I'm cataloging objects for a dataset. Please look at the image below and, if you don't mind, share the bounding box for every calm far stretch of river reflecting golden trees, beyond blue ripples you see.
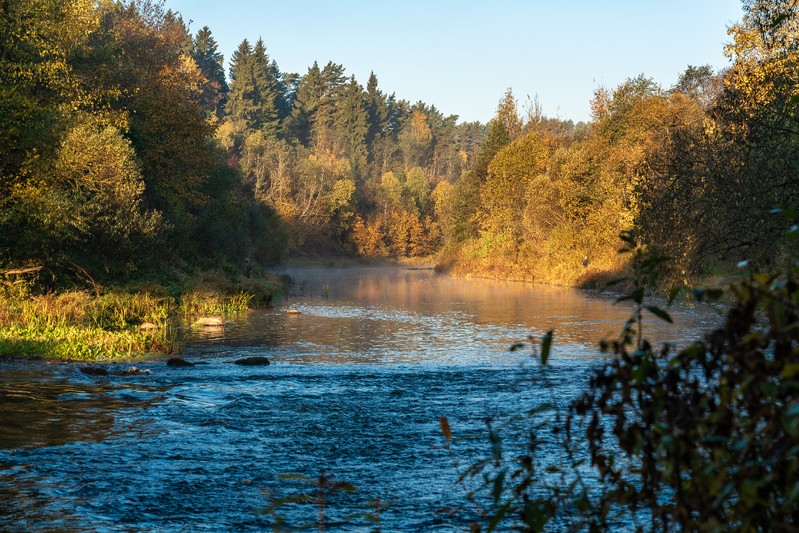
[209,267,717,364]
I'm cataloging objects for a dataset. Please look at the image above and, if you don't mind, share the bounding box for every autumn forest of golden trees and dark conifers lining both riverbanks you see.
[0,0,799,284]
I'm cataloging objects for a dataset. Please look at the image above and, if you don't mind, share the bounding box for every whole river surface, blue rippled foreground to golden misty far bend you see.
[0,267,719,531]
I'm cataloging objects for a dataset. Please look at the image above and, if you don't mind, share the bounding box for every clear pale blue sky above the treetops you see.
[166,0,742,122]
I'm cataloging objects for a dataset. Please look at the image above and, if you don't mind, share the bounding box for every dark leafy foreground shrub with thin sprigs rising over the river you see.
[450,234,799,531]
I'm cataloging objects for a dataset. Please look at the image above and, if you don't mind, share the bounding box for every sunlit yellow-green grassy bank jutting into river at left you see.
[0,272,286,361]
